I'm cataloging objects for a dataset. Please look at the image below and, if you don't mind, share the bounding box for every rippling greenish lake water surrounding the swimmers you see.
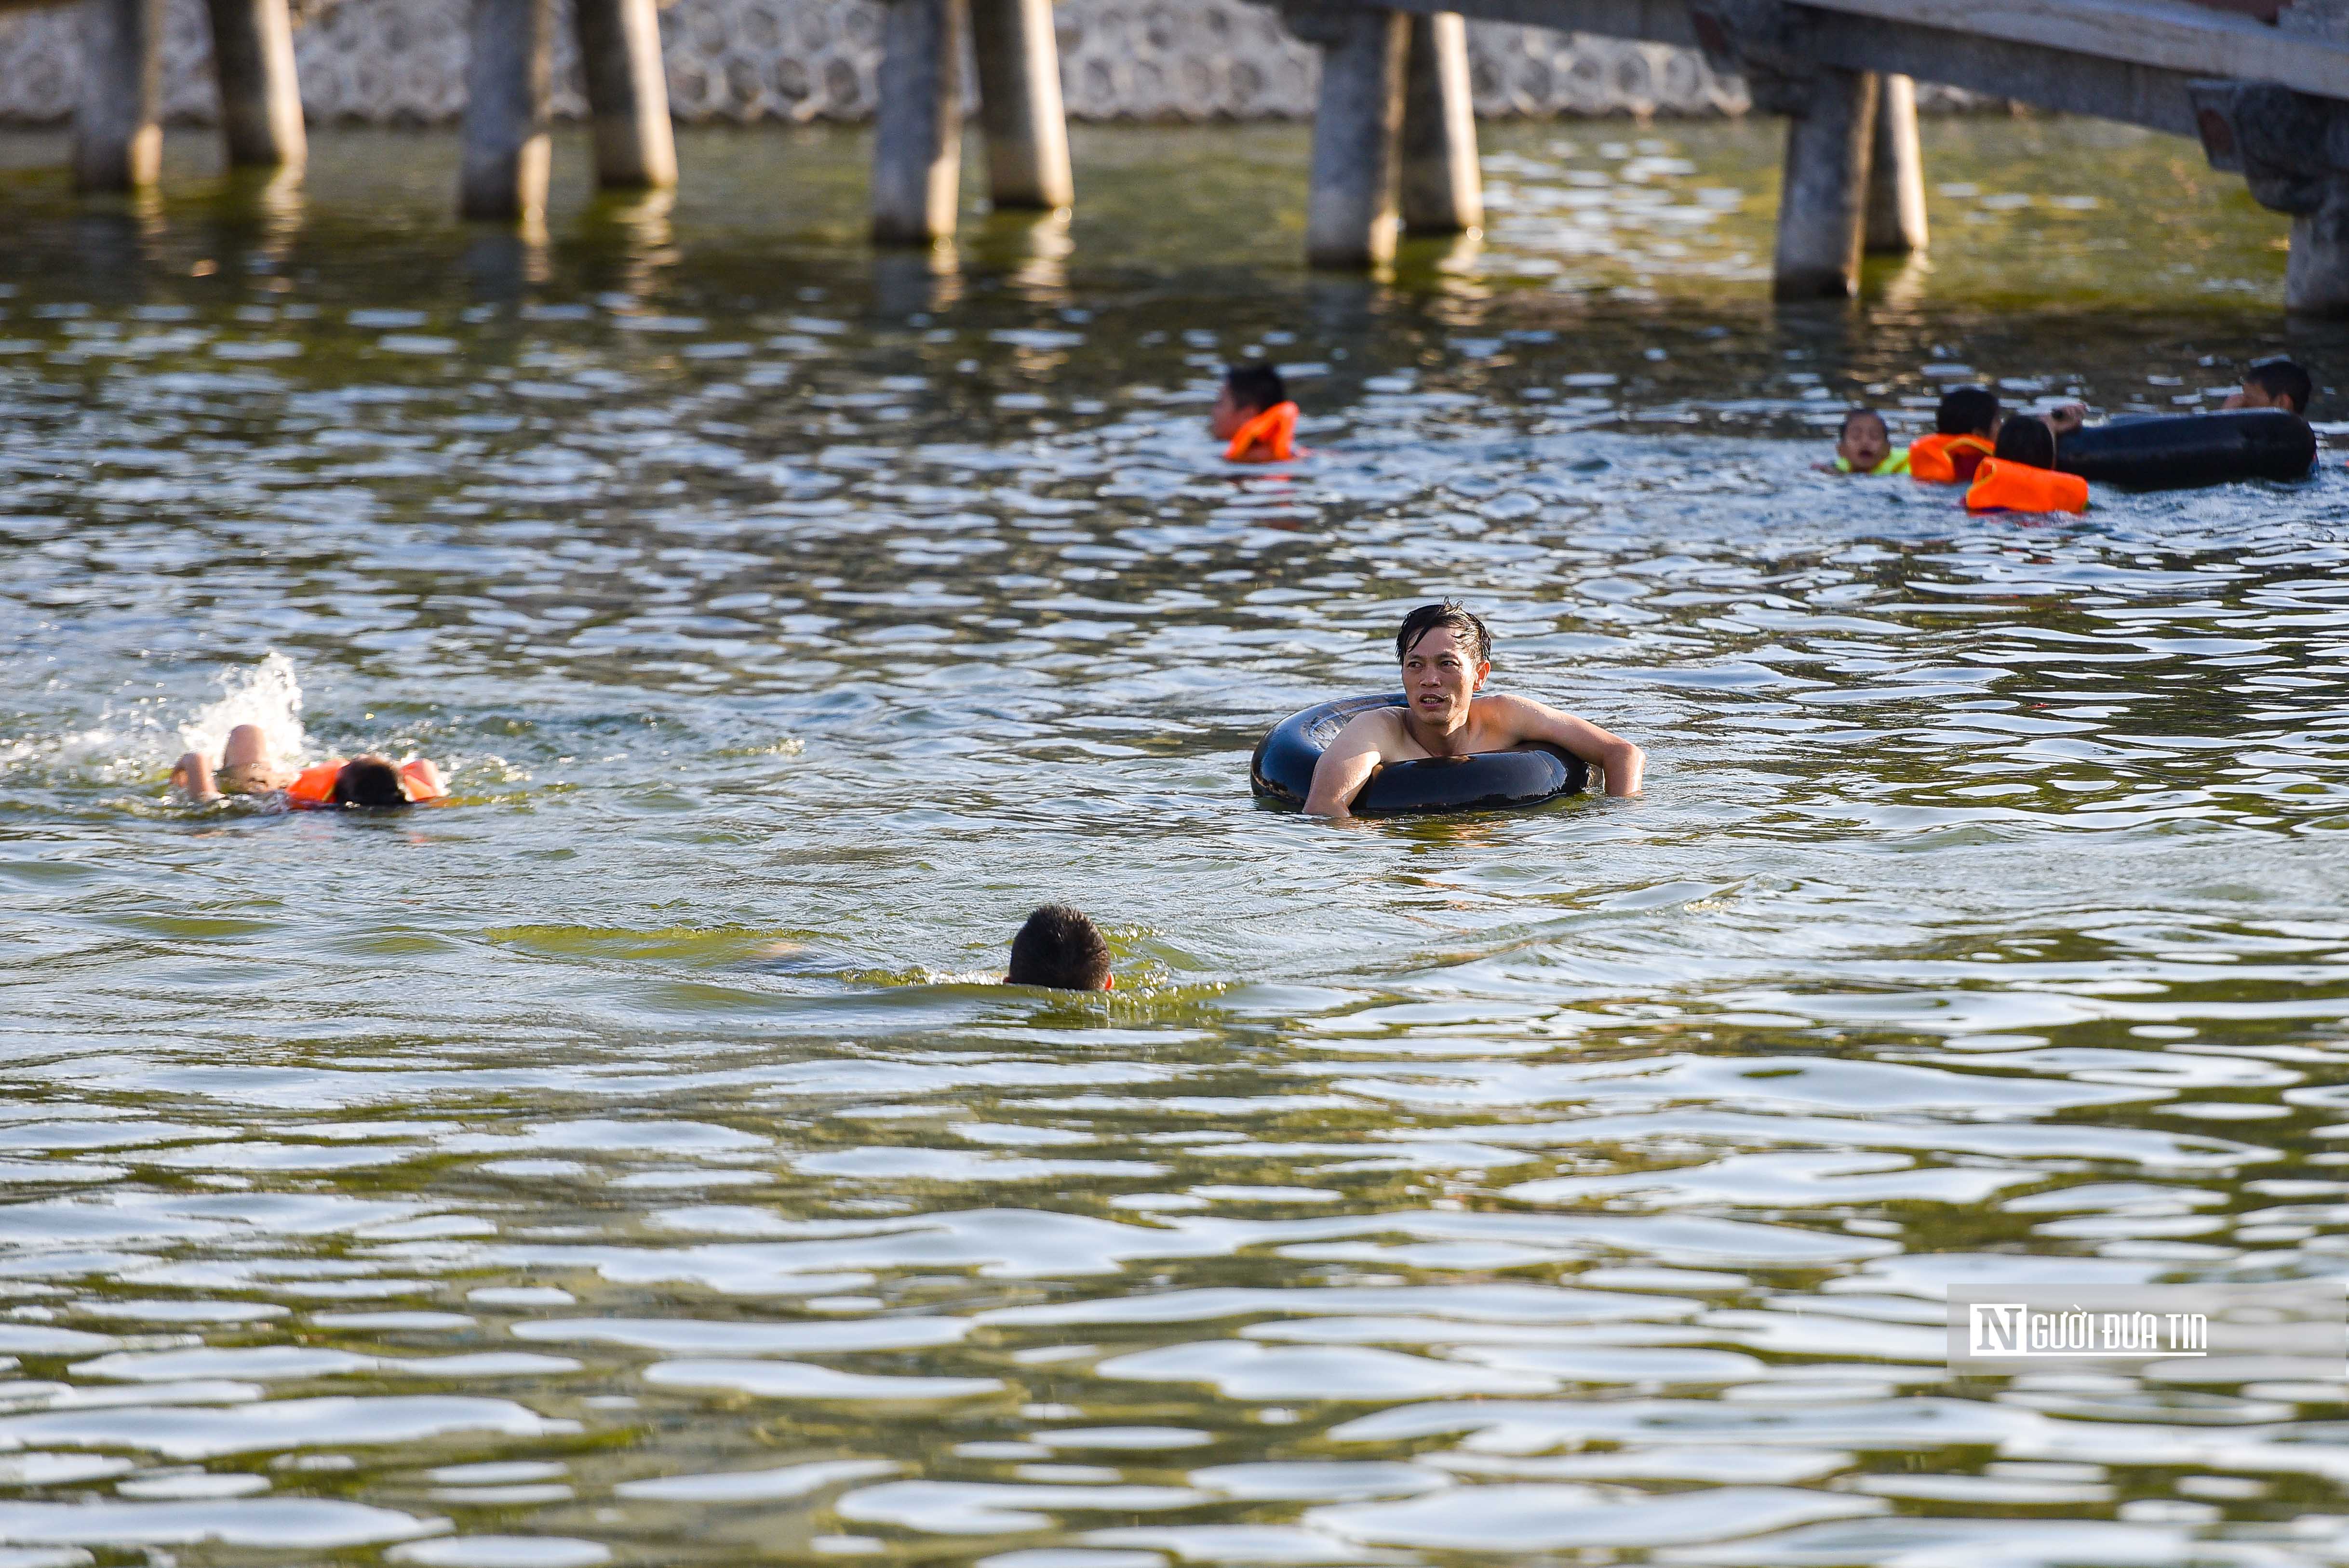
[0,120,2349,1568]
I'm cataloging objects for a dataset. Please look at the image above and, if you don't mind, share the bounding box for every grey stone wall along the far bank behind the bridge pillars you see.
[0,0,1745,124]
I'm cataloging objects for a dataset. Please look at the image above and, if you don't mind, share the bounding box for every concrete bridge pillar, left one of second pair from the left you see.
[456,0,554,223]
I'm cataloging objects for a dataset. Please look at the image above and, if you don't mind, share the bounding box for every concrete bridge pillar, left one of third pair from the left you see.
[872,0,970,244]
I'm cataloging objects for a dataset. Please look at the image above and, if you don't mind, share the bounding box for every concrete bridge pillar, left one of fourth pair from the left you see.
[1285,7,1412,270]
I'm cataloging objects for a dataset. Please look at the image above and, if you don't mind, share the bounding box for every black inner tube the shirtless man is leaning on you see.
[1248,693,1590,817]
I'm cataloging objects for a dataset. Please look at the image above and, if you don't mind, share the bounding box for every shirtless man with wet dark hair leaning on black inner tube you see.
[1306,603,1647,817]
